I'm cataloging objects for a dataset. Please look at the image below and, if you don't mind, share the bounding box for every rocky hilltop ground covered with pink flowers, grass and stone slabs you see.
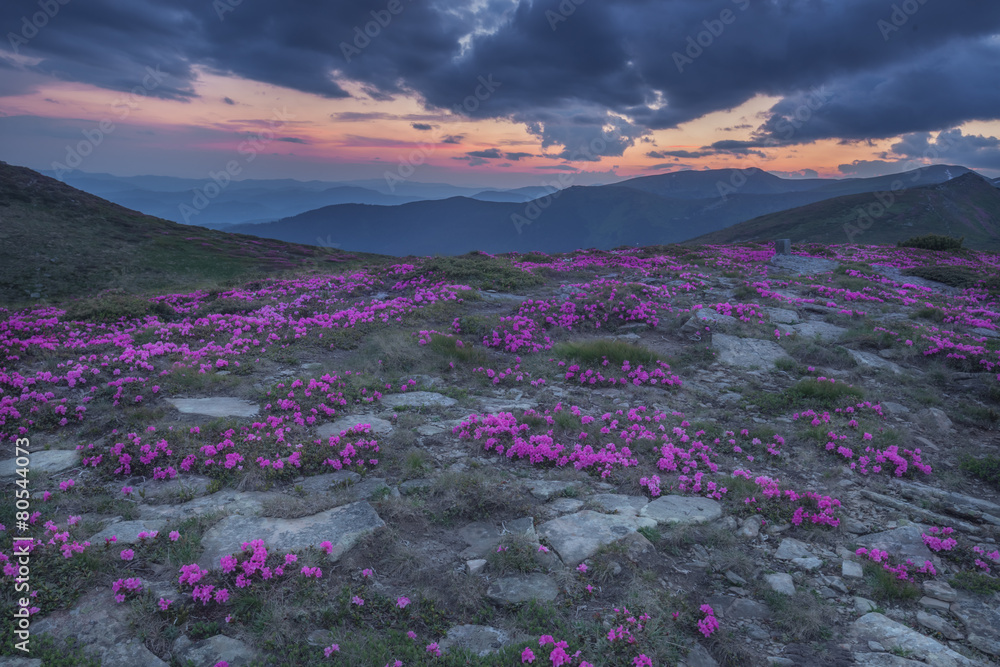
[0,247,1000,667]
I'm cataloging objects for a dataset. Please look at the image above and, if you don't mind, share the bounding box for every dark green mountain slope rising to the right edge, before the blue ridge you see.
[690,172,1000,250]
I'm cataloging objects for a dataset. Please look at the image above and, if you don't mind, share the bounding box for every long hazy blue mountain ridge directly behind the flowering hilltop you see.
[223,165,969,255]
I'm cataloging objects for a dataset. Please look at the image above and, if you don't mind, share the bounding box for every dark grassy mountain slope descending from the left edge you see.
[0,162,368,305]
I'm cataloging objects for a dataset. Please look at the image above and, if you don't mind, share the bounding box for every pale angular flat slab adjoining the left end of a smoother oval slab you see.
[538,510,656,567]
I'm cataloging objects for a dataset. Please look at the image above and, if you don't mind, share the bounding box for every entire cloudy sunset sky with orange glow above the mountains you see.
[0,0,1000,187]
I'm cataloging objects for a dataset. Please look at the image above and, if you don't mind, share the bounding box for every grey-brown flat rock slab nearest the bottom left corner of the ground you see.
[31,587,167,667]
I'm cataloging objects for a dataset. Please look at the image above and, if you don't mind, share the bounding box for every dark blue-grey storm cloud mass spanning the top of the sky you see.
[0,0,1000,161]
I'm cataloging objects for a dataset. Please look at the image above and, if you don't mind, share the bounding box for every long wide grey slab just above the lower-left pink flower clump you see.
[198,501,385,569]
